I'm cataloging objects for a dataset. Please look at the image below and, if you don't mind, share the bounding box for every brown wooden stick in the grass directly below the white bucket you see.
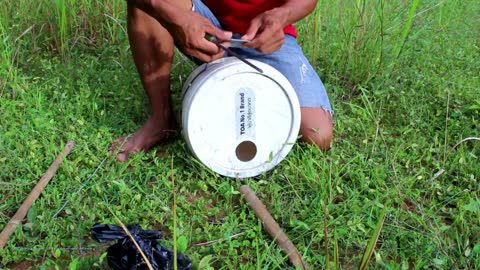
[240,185,309,269]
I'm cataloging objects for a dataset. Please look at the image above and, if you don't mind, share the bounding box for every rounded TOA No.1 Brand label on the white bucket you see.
[235,87,255,139]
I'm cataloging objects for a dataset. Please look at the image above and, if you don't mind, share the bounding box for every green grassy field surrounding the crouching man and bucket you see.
[0,0,480,269]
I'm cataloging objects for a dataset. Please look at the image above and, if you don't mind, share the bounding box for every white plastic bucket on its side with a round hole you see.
[181,57,300,178]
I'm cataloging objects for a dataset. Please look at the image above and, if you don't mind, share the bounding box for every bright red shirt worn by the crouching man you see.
[203,0,297,37]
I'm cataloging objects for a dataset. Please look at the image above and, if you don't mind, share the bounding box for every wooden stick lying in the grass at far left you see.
[0,141,75,249]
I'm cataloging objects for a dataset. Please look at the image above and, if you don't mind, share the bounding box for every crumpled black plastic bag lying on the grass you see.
[91,224,192,270]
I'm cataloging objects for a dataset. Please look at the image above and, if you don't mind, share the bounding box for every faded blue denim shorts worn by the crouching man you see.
[193,0,332,112]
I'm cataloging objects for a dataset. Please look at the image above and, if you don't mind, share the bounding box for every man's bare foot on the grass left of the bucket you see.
[109,118,178,161]
